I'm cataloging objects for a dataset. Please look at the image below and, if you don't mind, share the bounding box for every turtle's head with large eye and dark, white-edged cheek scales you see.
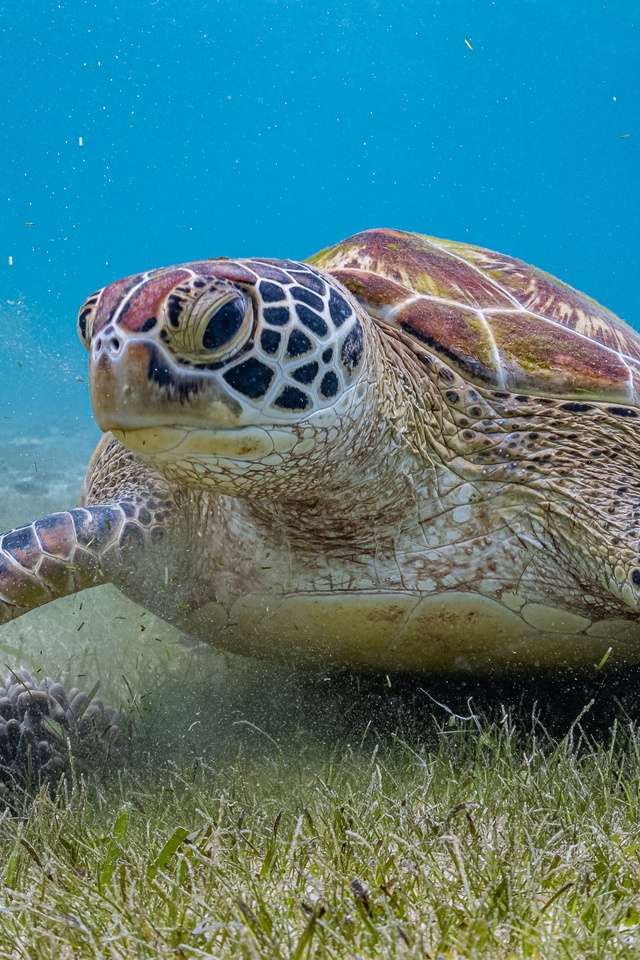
[78,259,376,492]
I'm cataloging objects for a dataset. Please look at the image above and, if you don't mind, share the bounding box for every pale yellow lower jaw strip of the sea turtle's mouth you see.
[111,424,300,461]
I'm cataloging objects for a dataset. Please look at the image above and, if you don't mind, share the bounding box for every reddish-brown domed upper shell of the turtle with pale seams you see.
[309,229,640,403]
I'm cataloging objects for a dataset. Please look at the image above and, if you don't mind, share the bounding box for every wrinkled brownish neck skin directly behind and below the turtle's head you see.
[152,322,428,555]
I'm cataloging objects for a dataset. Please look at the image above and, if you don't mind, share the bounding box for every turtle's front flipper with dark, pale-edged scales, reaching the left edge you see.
[0,499,164,623]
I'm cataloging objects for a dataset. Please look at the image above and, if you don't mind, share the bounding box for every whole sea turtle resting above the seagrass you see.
[0,229,640,671]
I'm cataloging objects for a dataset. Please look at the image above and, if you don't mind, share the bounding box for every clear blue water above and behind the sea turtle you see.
[0,0,640,431]
